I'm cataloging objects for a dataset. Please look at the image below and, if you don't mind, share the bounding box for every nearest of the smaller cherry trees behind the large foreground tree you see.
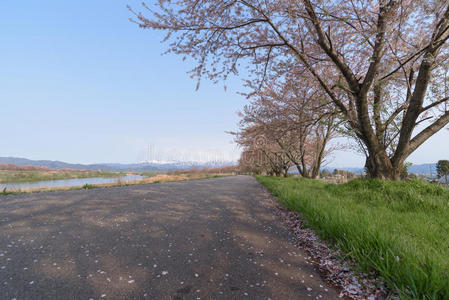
[237,78,339,178]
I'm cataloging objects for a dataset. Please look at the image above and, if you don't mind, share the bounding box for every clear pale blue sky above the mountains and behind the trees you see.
[0,0,448,167]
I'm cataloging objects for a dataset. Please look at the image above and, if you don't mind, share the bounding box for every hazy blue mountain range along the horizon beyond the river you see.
[0,157,236,171]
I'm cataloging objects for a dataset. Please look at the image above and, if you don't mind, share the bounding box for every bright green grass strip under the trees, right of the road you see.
[257,176,449,299]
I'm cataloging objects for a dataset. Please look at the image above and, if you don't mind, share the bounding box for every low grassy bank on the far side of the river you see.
[0,170,124,183]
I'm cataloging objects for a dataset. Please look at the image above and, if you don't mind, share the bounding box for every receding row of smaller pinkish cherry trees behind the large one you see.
[234,78,339,178]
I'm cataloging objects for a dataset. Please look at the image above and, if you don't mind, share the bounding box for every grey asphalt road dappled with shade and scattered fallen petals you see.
[0,176,338,300]
